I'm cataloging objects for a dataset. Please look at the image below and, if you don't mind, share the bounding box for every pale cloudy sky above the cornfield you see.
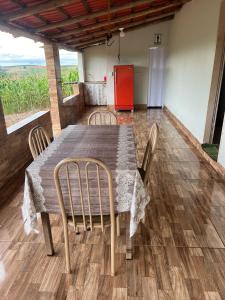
[0,31,77,66]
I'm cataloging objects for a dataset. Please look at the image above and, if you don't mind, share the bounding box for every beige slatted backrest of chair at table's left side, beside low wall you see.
[28,125,51,159]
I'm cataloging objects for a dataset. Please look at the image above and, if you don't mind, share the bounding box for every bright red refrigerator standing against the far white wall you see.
[114,65,134,111]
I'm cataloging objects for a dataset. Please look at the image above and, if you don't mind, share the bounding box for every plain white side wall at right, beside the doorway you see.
[165,0,221,143]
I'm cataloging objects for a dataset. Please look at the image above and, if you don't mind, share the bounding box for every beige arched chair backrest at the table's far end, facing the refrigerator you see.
[88,110,117,125]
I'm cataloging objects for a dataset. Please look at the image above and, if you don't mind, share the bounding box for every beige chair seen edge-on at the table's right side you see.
[138,123,159,186]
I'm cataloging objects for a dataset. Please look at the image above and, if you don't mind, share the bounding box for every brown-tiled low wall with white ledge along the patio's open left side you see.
[0,84,85,205]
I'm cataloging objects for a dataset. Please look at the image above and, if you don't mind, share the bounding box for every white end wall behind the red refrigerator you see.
[84,21,171,104]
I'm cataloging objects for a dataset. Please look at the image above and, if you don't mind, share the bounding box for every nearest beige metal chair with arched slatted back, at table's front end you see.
[54,158,115,276]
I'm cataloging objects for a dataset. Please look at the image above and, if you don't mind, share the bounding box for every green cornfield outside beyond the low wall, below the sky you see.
[0,66,79,115]
